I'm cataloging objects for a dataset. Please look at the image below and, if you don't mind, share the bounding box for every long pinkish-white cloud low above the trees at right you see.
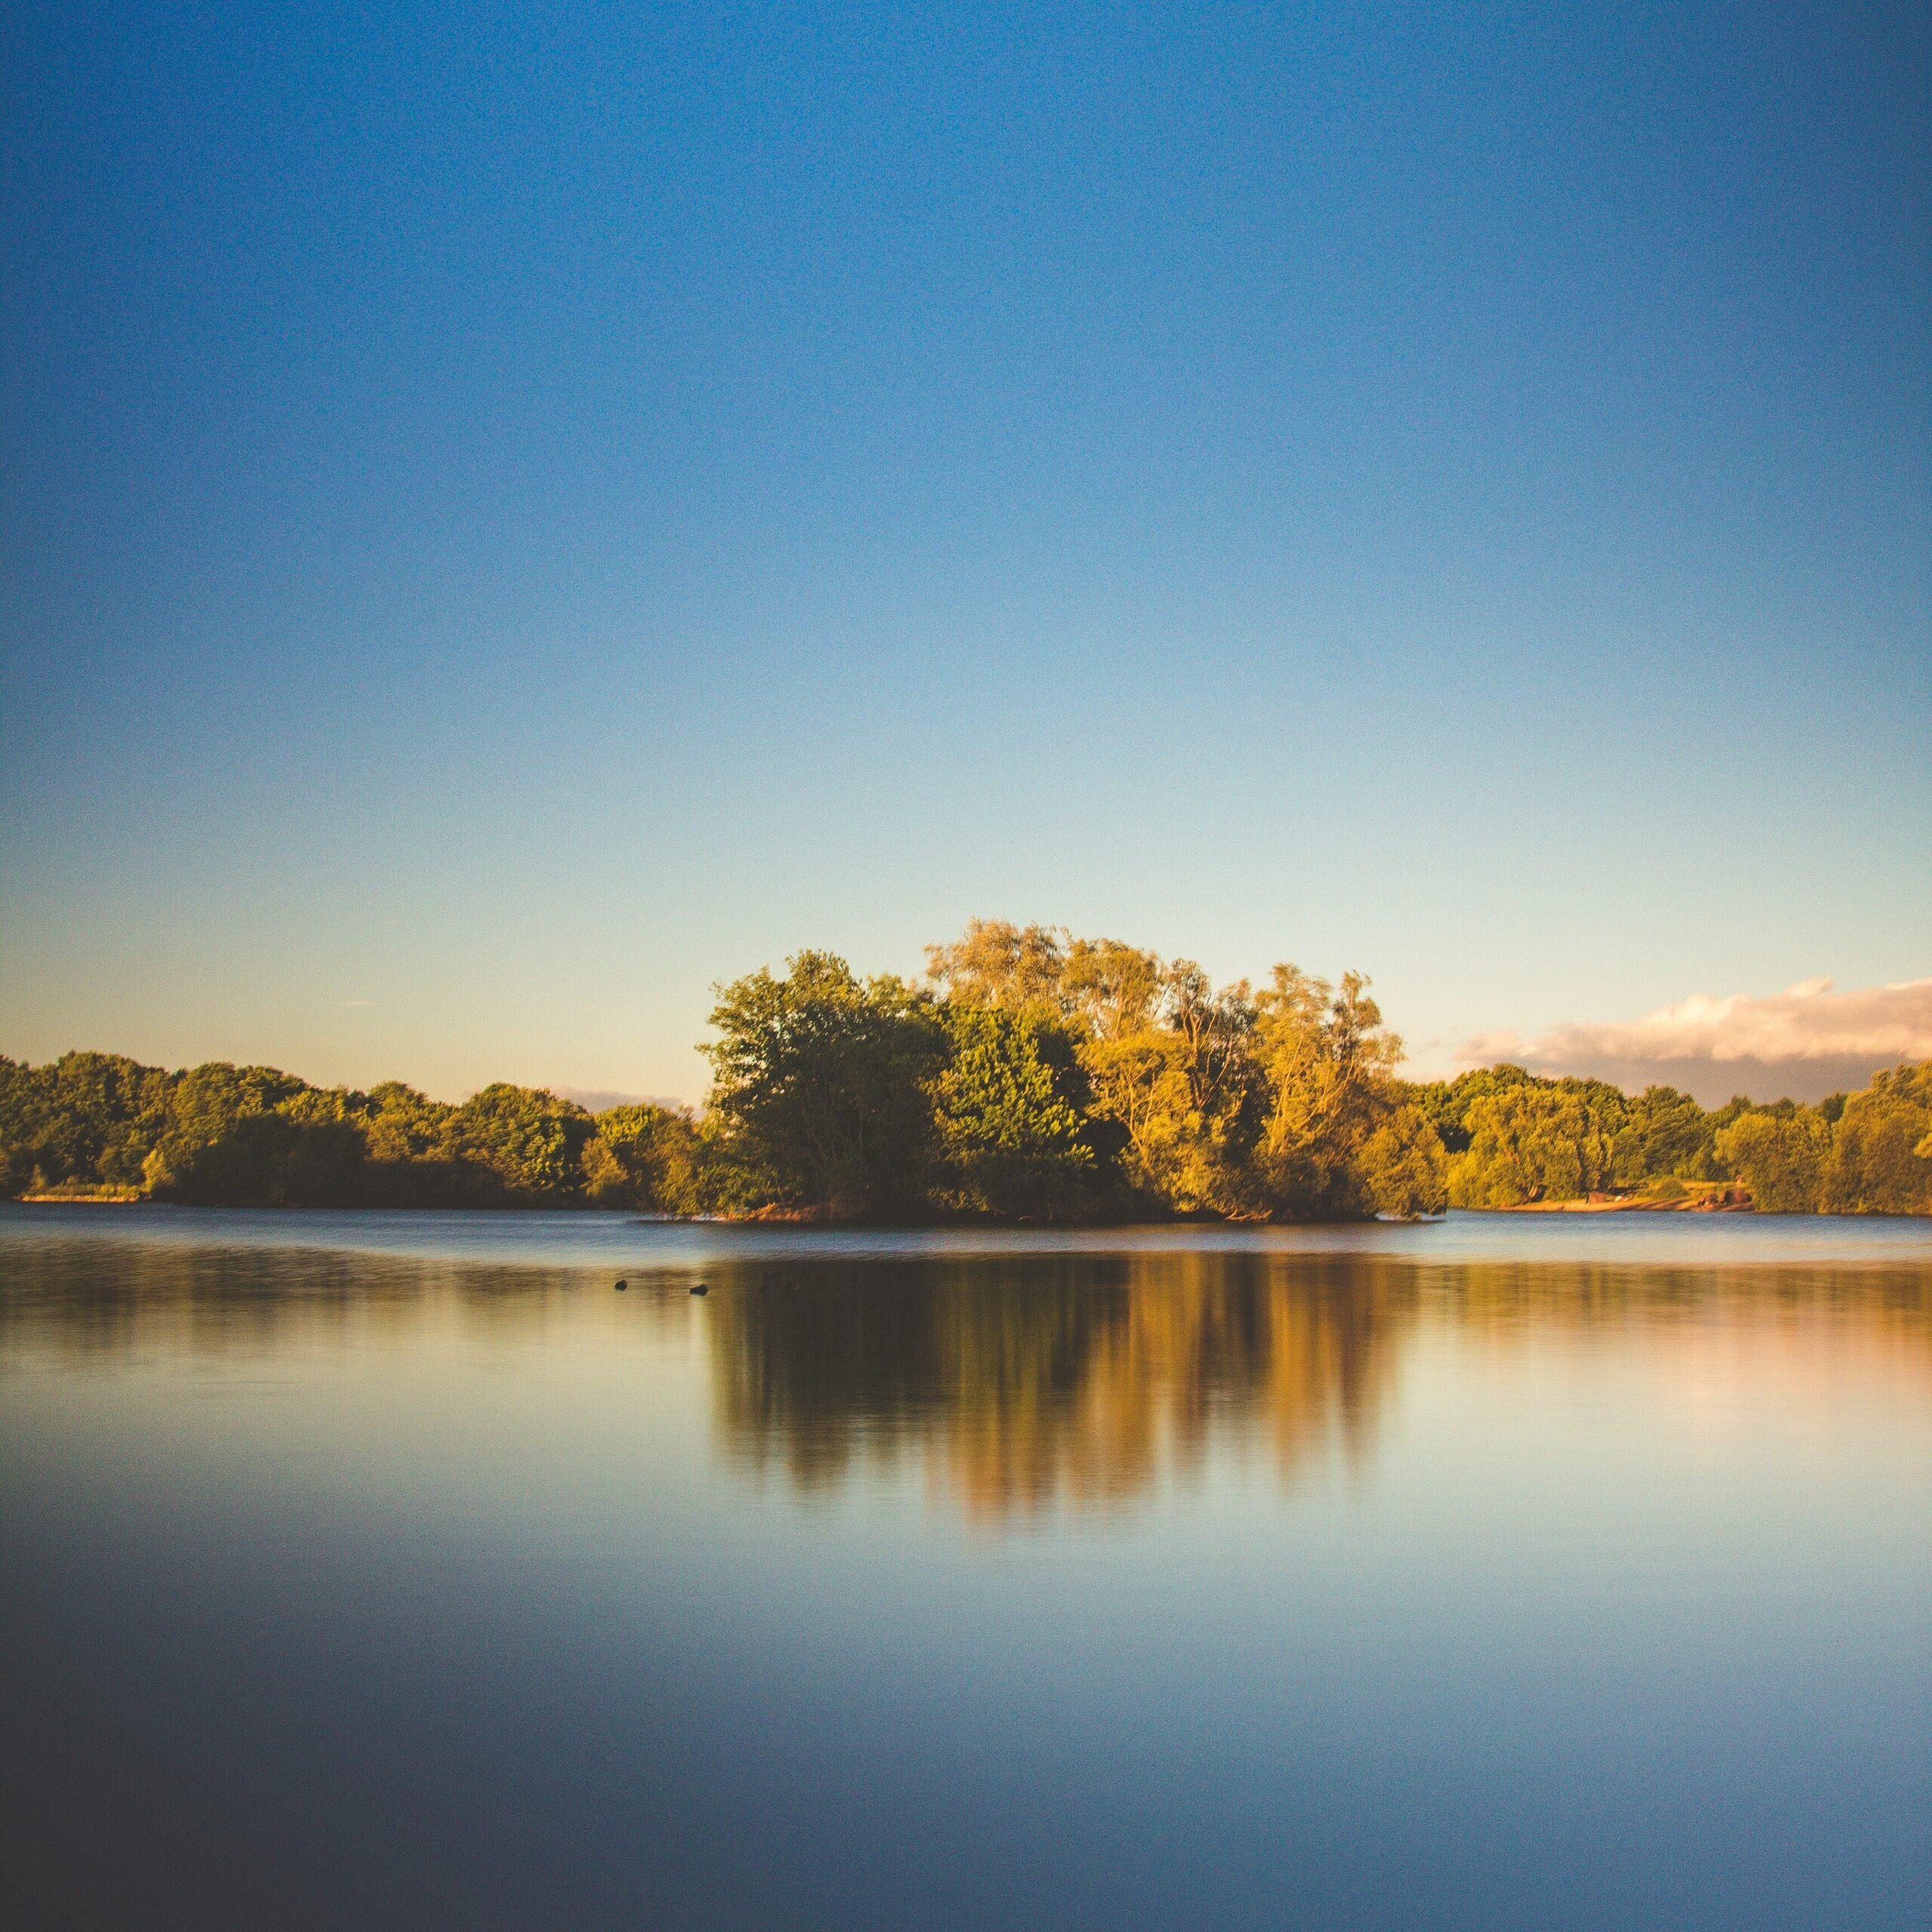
[1457,980,1932,1105]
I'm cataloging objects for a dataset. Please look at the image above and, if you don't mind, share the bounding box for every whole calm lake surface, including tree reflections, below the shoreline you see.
[0,1208,1932,1932]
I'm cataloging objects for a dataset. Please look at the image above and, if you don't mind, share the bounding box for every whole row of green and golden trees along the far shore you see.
[0,920,1932,1221]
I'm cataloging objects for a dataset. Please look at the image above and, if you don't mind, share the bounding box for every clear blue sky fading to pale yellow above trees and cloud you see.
[0,0,1932,1097]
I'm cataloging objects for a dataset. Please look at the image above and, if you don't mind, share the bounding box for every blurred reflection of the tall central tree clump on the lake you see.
[711,1256,1418,1517]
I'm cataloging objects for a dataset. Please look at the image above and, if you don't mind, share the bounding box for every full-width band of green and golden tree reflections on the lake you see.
[0,1242,1932,1522]
